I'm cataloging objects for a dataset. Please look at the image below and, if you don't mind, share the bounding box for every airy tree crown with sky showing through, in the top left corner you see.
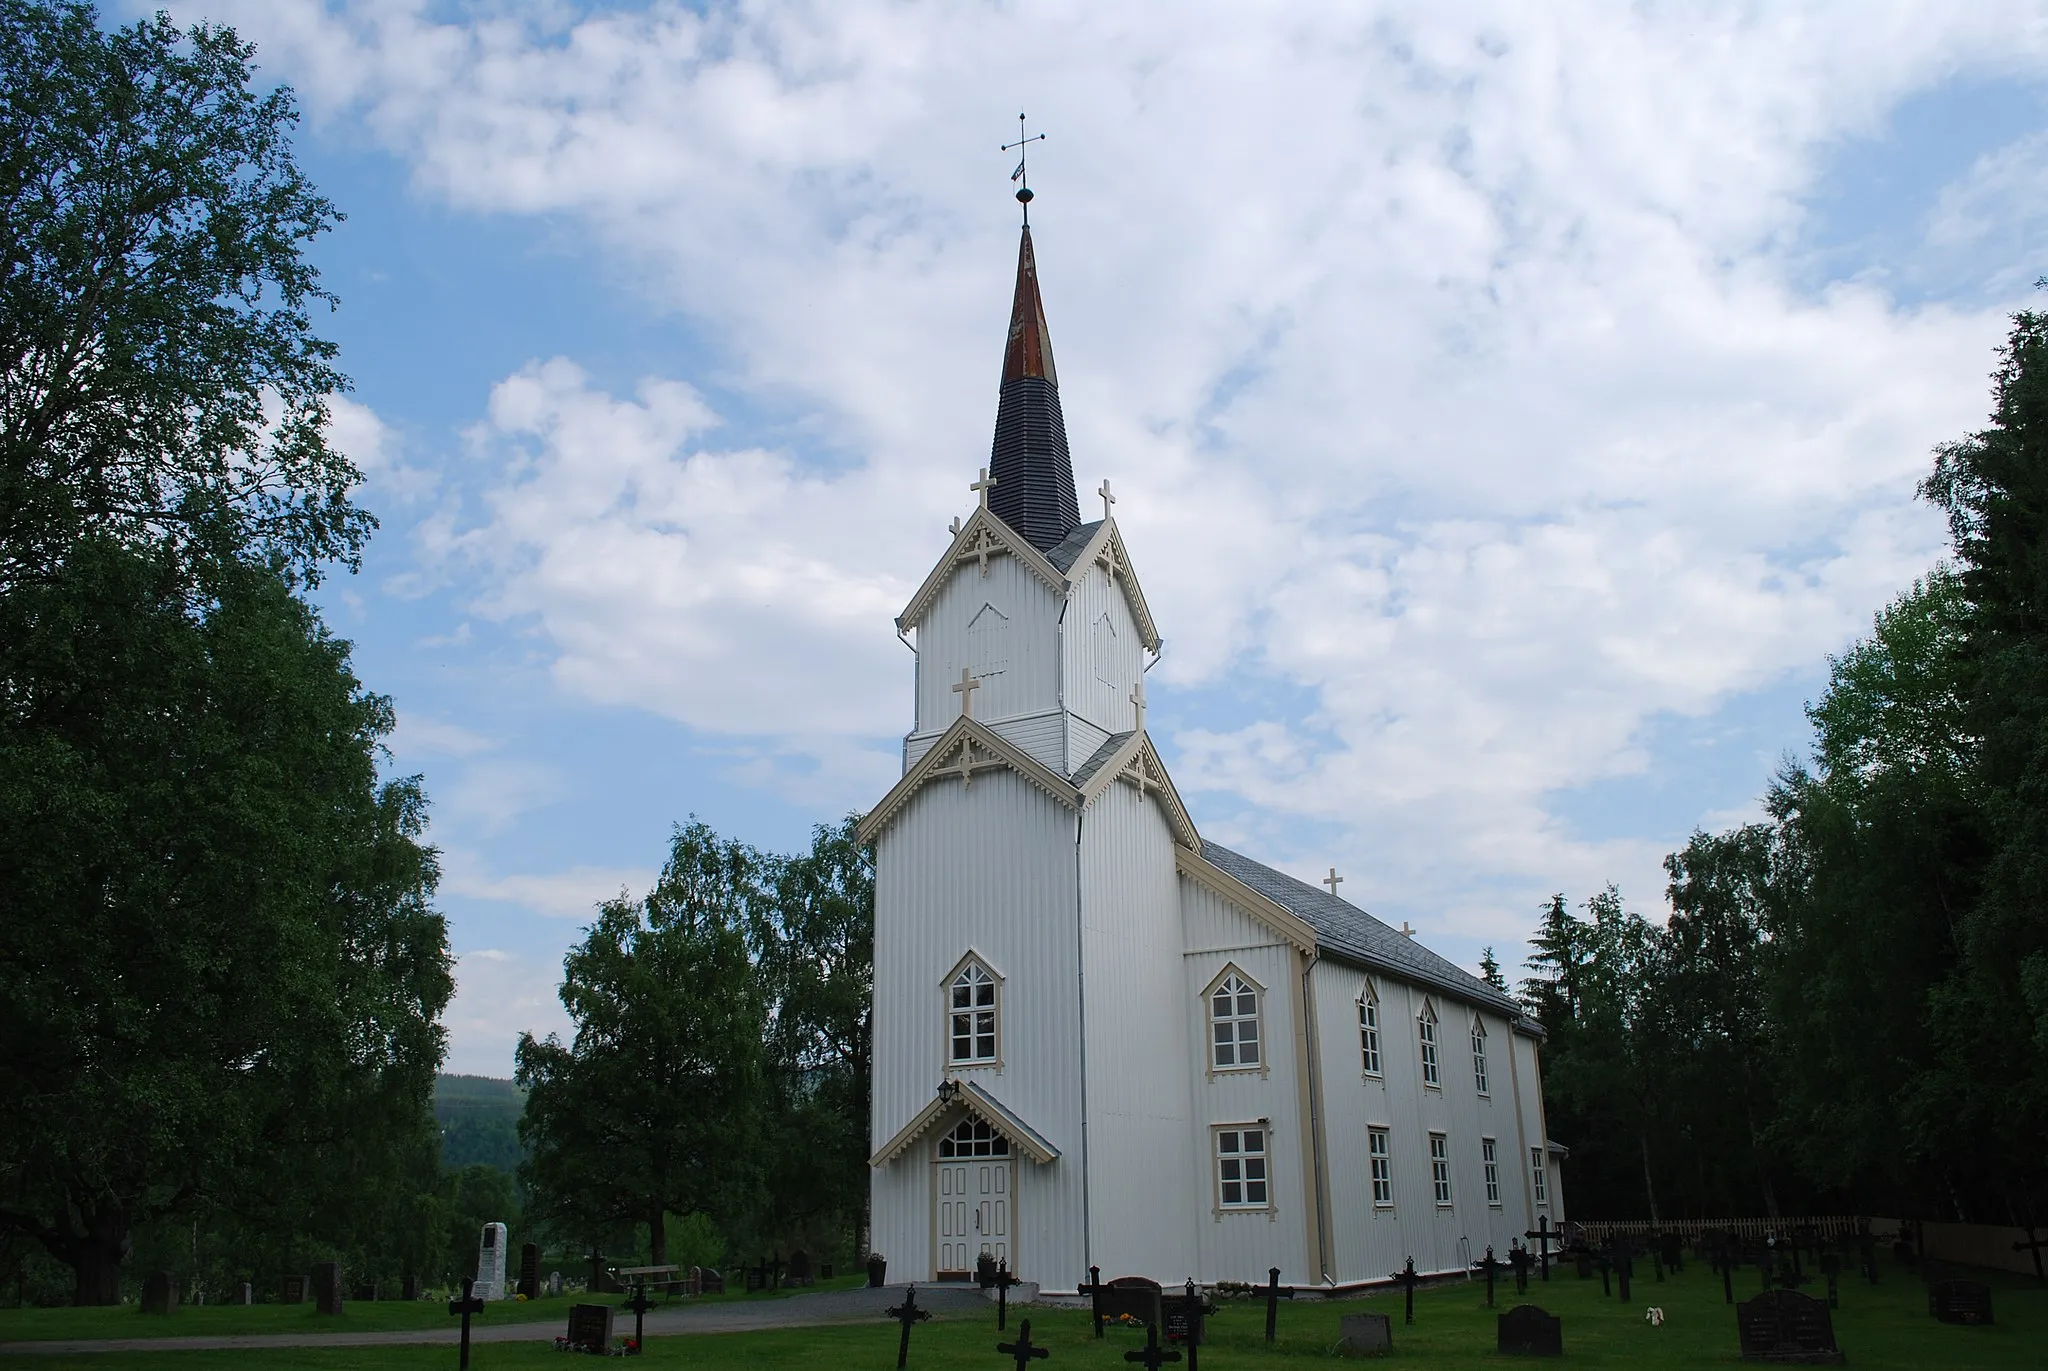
[0,0,373,594]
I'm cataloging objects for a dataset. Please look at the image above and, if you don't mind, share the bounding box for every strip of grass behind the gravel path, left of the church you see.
[0,1277,866,1342]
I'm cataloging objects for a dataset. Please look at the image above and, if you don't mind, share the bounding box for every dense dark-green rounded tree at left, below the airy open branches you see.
[0,539,453,1303]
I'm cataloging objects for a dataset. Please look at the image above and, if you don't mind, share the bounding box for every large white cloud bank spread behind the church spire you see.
[192,0,2044,937]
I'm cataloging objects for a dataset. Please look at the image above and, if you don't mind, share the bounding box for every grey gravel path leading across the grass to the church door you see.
[0,1285,987,1357]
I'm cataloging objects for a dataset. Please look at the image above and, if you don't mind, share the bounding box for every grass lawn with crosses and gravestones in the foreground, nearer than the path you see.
[18,1266,2048,1371]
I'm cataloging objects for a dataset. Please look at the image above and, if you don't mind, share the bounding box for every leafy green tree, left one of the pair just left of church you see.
[516,820,770,1262]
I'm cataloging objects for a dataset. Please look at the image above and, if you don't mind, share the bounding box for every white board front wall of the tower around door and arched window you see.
[870,771,1085,1289]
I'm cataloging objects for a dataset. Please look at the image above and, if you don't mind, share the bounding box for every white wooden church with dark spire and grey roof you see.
[862,223,1563,1291]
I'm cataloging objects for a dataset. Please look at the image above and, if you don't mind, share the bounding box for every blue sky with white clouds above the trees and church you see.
[132,0,2048,1076]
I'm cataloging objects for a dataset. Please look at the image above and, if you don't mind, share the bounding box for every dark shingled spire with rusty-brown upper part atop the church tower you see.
[989,223,1081,551]
